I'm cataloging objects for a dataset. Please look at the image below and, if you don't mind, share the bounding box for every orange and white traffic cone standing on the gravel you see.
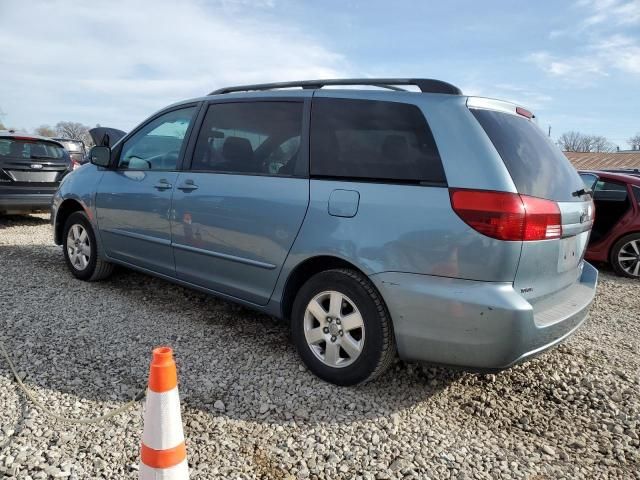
[138,347,189,480]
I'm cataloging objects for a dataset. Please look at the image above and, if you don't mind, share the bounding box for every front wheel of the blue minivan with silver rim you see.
[62,212,113,282]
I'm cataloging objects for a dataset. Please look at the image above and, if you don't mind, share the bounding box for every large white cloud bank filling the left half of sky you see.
[0,0,350,129]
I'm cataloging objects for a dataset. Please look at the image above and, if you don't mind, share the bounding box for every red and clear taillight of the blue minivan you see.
[449,189,562,241]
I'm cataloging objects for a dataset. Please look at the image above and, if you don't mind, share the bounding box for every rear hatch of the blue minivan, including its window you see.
[467,99,595,304]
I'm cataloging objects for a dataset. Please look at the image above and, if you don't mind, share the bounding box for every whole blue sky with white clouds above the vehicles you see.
[0,0,640,148]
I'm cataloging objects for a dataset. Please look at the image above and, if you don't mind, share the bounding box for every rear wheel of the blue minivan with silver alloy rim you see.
[291,269,396,386]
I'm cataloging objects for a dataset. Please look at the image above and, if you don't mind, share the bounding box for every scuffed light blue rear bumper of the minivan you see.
[371,262,598,369]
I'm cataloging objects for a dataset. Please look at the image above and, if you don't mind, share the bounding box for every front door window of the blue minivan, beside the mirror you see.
[118,107,196,170]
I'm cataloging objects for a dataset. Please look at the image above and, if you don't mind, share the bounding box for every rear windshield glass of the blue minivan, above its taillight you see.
[471,109,584,202]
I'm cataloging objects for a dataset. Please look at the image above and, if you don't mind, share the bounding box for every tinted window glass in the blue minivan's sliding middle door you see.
[191,102,303,176]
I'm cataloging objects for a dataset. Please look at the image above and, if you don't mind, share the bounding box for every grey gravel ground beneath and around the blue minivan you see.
[0,216,640,480]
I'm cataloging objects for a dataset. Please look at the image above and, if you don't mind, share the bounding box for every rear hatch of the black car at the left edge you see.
[0,136,69,190]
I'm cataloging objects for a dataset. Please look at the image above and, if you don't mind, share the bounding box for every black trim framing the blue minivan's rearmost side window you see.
[309,95,449,188]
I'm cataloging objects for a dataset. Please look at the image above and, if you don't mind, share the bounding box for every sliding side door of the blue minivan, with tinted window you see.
[172,99,309,305]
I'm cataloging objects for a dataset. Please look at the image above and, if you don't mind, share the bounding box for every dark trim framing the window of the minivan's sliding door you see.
[183,96,311,178]
